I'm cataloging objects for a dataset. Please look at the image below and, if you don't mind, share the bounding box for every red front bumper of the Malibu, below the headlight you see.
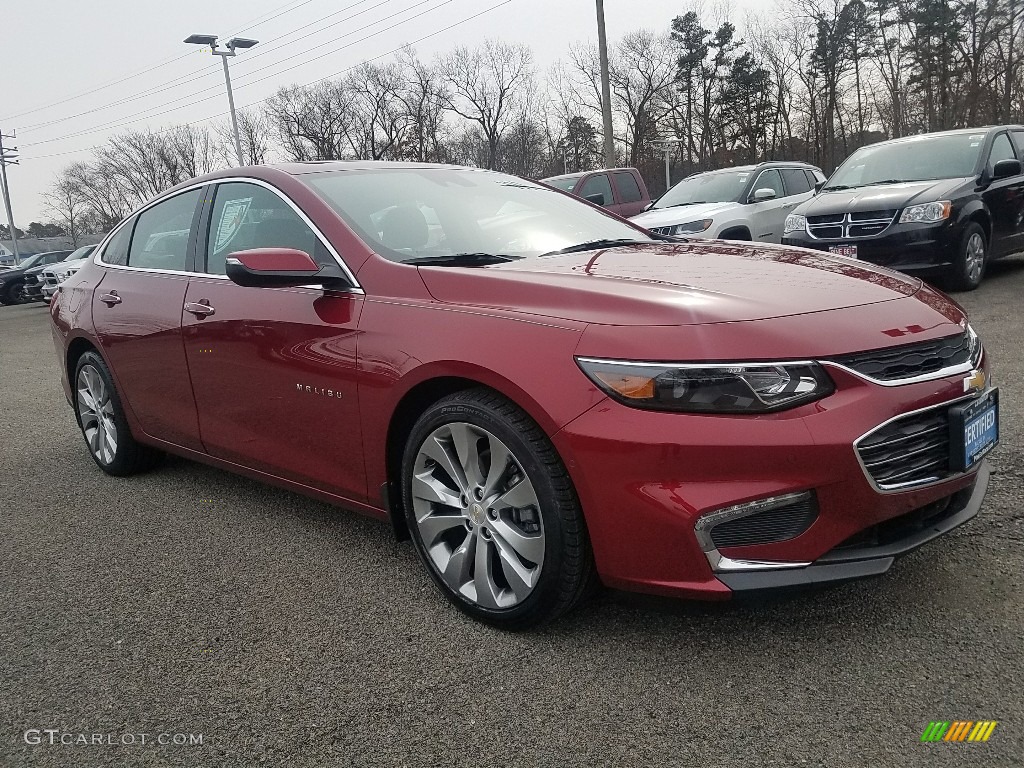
[554,369,988,599]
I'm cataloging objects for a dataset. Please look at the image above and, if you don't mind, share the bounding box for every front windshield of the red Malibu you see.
[302,168,654,263]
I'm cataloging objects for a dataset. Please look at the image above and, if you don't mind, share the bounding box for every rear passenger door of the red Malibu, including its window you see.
[92,187,203,451]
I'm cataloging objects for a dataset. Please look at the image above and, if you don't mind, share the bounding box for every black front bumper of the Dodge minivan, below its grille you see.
[782,222,963,273]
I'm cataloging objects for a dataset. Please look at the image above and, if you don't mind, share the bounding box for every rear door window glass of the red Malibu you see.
[128,189,202,271]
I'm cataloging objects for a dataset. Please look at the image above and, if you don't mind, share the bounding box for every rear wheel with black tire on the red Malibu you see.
[73,352,162,477]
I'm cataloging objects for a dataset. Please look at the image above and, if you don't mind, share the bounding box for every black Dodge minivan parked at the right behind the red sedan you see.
[782,125,1024,291]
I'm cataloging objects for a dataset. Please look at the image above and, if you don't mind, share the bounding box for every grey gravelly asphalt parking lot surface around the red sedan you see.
[6,257,1024,768]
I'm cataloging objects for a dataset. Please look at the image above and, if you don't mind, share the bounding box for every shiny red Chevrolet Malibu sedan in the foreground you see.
[51,163,998,628]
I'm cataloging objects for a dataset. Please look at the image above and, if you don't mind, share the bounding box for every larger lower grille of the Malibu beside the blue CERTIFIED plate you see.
[857,404,951,490]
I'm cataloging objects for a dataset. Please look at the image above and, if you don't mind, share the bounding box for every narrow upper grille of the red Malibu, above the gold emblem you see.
[831,331,981,381]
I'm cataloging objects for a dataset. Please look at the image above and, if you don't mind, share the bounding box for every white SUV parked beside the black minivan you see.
[632,162,825,243]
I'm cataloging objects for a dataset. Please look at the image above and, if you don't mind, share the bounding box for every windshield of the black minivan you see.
[824,133,985,191]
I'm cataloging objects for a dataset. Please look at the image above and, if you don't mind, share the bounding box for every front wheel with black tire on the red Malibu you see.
[402,388,594,630]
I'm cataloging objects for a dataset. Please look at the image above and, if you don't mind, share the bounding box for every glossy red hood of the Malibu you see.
[420,241,922,326]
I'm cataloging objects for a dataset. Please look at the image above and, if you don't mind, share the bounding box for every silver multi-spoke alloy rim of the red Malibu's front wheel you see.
[412,422,545,609]
